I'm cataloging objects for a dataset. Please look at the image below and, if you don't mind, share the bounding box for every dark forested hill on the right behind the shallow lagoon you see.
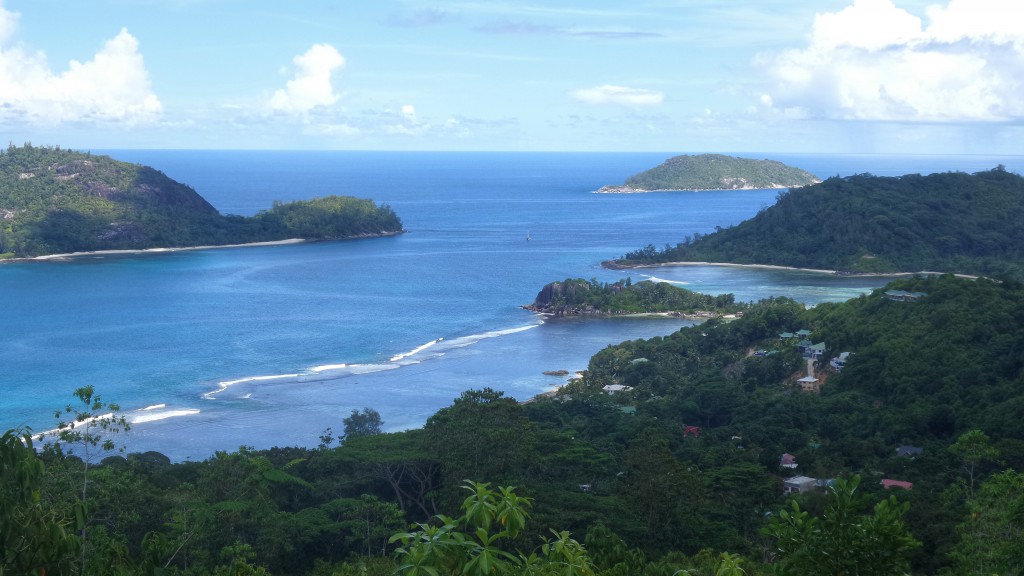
[610,167,1024,278]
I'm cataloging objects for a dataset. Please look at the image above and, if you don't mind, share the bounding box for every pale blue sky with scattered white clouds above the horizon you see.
[0,0,1024,155]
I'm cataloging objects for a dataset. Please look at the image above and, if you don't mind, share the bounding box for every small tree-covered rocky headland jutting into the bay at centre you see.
[523,278,745,316]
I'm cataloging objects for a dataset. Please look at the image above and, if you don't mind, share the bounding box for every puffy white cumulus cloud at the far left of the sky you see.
[0,15,162,125]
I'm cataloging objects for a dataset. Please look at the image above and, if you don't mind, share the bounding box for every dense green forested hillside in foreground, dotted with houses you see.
[0,276,1024,576]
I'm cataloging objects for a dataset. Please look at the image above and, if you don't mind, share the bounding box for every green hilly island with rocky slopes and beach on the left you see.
[0,145,402,259]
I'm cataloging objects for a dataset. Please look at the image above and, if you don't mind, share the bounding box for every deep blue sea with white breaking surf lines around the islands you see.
[0,151,1024,460]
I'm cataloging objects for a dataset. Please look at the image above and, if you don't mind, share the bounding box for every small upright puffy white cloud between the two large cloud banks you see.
[267,44,345,114]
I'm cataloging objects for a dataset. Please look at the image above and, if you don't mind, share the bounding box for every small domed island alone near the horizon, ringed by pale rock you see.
[597,154,821,194]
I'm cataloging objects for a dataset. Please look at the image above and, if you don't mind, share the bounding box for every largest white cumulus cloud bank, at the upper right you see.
[756,0,1024,122]
